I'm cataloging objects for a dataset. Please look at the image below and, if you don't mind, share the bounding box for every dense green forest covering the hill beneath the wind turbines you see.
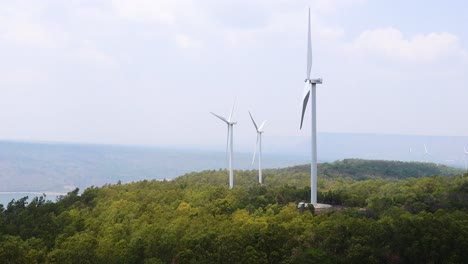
[0,160,468,263]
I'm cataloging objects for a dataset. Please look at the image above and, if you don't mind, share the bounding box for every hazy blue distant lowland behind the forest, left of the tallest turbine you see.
[0,141,308,204]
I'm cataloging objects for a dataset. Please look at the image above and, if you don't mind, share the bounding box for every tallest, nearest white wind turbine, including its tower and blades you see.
[300,8,322,207]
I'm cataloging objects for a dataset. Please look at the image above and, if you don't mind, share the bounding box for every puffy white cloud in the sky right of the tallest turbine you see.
[349,28,466,62]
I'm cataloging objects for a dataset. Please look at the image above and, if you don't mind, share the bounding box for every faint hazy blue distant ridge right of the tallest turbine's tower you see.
[288,133,468,168]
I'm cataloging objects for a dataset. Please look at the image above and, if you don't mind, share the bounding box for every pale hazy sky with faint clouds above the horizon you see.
[0,0,468,149]
